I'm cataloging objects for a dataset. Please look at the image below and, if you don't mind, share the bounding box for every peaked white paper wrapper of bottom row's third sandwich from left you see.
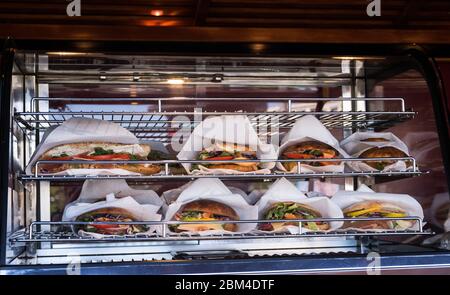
[256,178,343,234]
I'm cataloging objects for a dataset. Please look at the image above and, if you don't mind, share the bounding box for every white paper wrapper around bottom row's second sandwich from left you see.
[165,178,258,236]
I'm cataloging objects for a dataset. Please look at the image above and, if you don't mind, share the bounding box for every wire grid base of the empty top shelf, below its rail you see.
[15,112,415,142]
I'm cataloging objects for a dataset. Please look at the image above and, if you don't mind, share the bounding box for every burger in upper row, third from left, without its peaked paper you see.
[281,141,340,171]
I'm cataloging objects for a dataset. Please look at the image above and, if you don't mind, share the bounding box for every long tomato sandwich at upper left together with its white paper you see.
[26,118,161,175]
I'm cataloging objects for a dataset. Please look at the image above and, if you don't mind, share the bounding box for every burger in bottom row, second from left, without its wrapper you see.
[170,200,239,232]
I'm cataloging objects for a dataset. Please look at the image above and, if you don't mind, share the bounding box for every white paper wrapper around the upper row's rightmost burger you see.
[341,132,409,171]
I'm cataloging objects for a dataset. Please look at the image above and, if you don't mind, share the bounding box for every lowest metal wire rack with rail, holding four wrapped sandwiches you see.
[9,216,432,245]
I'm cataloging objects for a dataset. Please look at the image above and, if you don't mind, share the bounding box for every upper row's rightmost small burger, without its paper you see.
[359,146,411,170]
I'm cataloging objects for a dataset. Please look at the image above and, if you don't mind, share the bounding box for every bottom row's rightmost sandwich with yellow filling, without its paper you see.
[343,201,415,230]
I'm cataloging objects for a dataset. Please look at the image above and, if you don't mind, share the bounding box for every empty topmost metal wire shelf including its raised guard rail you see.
[14,97,416,142]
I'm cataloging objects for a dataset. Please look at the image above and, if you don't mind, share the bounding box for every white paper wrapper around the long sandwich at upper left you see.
[25,118,146,175]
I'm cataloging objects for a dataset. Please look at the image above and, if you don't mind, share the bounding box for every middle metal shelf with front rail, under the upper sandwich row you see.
[19,157,428,181]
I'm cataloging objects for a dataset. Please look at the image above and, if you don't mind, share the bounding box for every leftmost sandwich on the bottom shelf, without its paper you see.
[75,208,148,235]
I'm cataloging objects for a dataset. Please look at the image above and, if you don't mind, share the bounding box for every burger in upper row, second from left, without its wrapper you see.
[193,143,259,172]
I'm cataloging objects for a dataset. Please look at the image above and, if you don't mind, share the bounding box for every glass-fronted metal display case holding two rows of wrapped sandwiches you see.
[1,46,450,274]
